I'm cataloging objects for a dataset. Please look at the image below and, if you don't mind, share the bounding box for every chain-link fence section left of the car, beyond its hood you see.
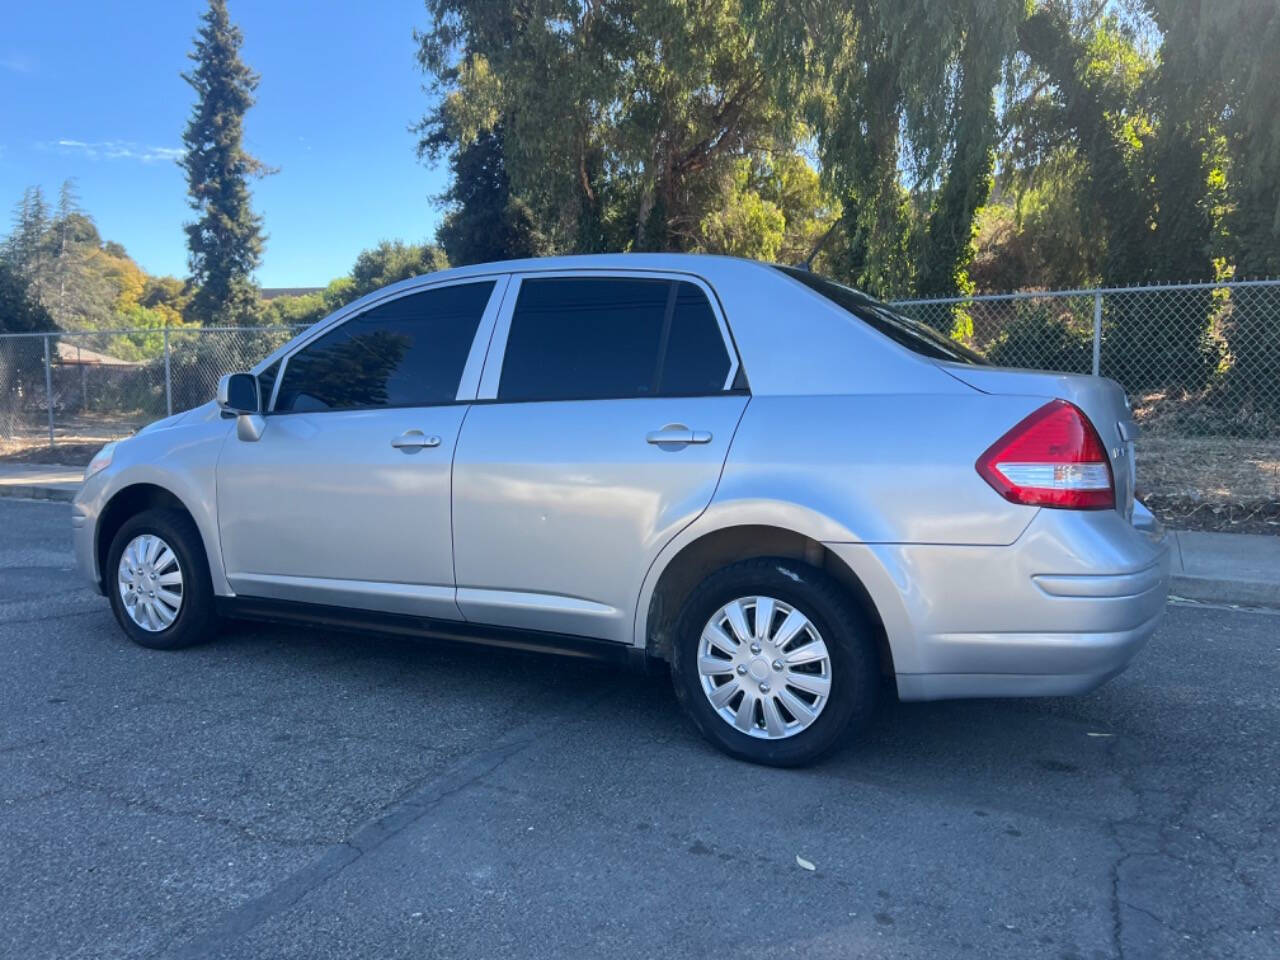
[0,326,305,458]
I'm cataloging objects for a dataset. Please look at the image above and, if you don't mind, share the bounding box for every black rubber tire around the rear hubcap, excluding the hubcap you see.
[672,557,879,767]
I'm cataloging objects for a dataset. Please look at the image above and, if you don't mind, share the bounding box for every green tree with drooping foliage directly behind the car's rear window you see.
[748,0,1025,296]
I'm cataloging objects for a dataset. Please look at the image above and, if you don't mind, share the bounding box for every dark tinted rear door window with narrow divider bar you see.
[498,276,731,401]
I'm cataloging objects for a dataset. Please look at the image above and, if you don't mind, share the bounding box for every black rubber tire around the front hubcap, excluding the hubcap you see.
[102,509,218,650]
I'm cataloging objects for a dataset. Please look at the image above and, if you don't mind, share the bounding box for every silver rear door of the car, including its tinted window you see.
[453,273,749,643]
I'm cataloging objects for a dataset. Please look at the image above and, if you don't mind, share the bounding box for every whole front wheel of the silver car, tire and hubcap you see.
[105,509,216,650]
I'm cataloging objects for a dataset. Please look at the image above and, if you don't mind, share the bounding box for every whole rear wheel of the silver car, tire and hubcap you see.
[672,558,879,767]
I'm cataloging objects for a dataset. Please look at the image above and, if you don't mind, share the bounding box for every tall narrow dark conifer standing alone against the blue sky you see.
[179,0,270,324]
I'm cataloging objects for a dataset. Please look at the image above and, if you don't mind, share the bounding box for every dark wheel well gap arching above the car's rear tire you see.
[645,526,893,677]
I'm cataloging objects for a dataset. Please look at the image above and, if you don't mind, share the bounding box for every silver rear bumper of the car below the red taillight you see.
[829,507,1170,700]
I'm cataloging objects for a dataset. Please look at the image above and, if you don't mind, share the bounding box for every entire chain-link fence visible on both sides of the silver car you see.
[0,280,1280,526]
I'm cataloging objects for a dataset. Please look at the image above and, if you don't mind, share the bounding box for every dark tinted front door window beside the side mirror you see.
[275,282,493,411]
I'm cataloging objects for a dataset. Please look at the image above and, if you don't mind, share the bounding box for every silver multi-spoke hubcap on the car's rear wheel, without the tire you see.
[698,596,831,740]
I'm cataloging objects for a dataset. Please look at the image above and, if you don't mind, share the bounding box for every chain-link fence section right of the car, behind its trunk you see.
[895,280,1280,526]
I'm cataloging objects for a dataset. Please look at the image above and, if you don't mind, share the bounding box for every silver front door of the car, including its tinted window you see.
[218,279,503,620]
